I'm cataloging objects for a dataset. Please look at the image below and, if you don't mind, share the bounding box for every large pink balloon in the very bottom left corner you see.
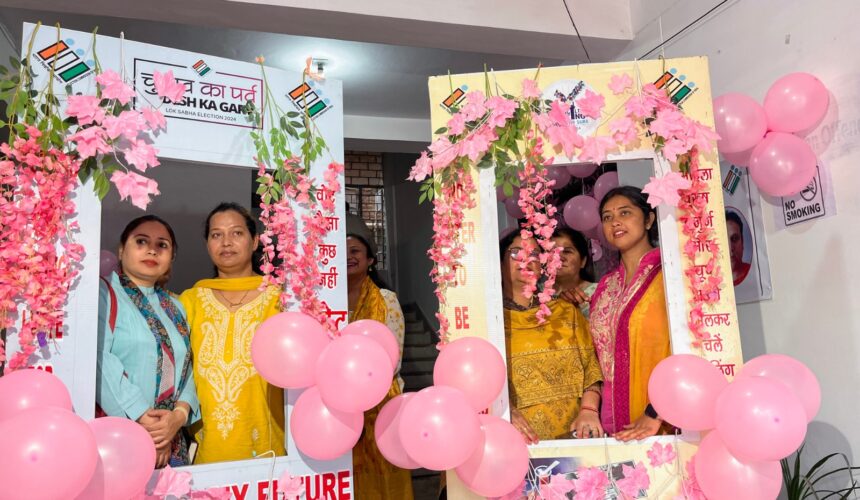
[0,406,99,500]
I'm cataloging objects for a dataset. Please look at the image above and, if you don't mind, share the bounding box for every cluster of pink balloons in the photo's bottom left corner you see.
[0,369,155,500]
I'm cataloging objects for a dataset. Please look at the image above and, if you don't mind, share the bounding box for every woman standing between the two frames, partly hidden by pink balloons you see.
[346,217,412,500]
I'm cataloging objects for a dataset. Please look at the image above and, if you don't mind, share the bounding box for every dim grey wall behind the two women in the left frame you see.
[101,160,253,293]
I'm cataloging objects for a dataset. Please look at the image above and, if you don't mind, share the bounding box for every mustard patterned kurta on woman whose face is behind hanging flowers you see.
[505,300,603,440]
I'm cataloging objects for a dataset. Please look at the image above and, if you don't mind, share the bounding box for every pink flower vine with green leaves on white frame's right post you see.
[245,57,343,333]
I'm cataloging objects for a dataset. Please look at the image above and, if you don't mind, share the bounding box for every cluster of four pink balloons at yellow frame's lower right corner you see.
[648,354,821,500]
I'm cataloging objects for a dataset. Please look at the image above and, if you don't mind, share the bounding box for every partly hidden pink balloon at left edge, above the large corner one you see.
[0,370,72,420]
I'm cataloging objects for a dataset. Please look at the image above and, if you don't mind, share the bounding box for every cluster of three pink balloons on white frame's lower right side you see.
[251,312,400,460]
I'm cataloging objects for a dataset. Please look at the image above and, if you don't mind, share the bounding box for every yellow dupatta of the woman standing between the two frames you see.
[349,278,412,500]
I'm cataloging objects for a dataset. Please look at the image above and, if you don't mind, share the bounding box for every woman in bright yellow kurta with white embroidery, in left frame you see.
[180,203,286,464]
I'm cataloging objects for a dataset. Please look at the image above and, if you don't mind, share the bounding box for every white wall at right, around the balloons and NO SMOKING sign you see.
[619,0,860,465]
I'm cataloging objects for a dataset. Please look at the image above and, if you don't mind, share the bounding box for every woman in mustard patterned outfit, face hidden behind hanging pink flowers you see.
[499,232,603,443]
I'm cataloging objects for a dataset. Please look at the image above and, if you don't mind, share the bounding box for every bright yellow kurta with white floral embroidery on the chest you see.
[180,276,286,464]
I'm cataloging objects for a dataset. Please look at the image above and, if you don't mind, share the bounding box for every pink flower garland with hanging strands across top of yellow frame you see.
[409,68,720,345]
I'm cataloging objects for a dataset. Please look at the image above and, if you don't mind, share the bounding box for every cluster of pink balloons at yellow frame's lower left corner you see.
[375,337,529,497]
